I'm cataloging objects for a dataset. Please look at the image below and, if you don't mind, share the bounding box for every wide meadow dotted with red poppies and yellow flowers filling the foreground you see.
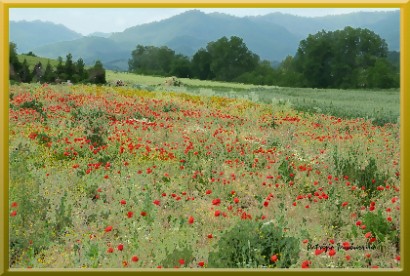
[9,83,400,271]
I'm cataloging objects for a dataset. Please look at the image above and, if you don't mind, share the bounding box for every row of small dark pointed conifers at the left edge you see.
[9,42,106,84]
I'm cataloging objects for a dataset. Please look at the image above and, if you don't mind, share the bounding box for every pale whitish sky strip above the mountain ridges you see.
[9,8,397,35]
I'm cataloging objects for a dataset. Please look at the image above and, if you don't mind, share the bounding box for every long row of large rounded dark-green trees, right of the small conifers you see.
[128,27,400,88]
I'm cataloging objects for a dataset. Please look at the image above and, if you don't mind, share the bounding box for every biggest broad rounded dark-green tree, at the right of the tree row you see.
[294,27,387,88]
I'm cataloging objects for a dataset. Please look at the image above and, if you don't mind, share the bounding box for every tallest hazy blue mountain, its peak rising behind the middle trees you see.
[110,10,299,60]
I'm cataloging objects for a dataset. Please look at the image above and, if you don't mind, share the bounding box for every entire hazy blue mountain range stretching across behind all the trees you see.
[10,10,400,70]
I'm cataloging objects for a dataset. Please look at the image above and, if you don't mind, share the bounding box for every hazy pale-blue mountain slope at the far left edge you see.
[9,20,82,53]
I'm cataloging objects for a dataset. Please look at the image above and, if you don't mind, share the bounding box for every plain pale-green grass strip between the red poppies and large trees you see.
[107,71,400,125]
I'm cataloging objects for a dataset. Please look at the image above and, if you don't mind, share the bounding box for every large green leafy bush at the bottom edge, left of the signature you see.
[208,220,299,268]
